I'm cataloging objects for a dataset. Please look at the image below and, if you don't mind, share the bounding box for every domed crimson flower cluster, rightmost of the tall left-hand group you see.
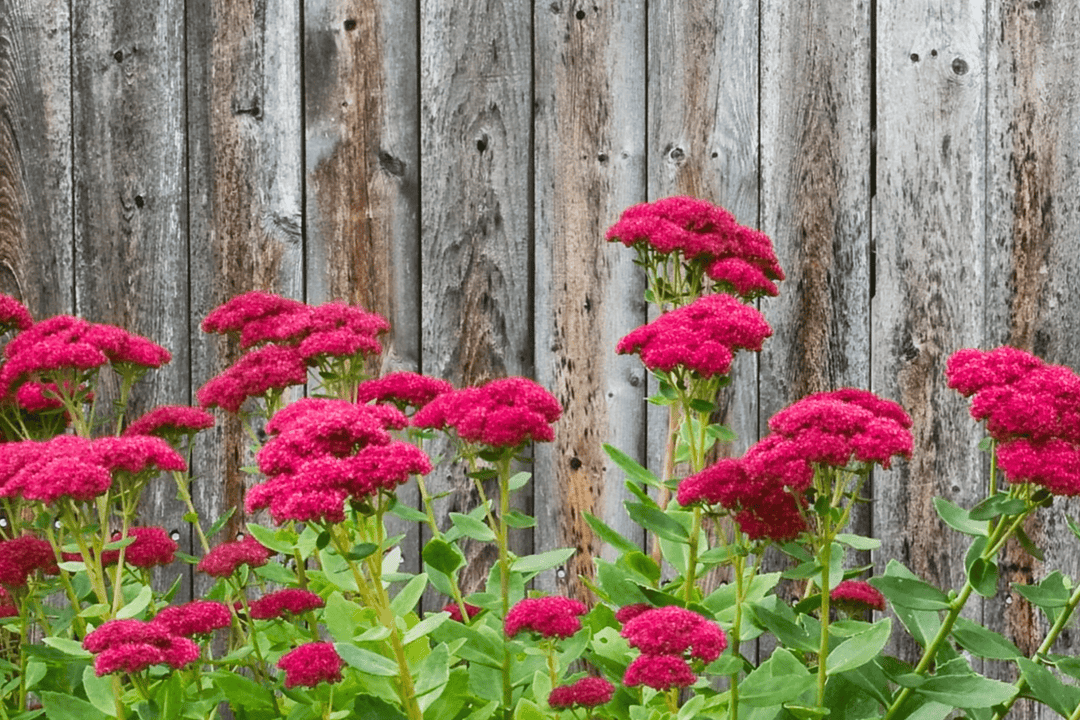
[413,378,563,448]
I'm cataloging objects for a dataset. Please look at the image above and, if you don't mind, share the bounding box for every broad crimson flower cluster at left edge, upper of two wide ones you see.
[0,315,172,399]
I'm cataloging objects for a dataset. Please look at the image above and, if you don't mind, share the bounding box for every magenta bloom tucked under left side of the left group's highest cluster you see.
[195,345,308,412]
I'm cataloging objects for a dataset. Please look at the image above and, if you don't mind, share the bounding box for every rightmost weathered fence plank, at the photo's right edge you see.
[984,0,1080,718]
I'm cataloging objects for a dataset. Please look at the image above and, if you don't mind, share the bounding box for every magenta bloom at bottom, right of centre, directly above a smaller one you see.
[620,606,728,662]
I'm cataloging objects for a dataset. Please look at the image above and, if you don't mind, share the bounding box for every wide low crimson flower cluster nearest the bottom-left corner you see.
[82,619,200,676]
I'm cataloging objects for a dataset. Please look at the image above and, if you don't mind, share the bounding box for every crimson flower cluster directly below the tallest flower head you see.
[616,295,772,378]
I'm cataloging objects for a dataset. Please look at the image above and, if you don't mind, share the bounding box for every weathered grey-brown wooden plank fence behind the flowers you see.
[0,0,1080,708]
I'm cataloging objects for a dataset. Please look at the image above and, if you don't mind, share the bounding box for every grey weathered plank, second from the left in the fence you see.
[71,0,190,586]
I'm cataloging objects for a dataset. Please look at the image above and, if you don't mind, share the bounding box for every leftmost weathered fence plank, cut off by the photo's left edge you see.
[0,0,75,320]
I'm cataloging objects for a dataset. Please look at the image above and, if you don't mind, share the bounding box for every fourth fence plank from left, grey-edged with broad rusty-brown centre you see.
[303,0,420,572]
